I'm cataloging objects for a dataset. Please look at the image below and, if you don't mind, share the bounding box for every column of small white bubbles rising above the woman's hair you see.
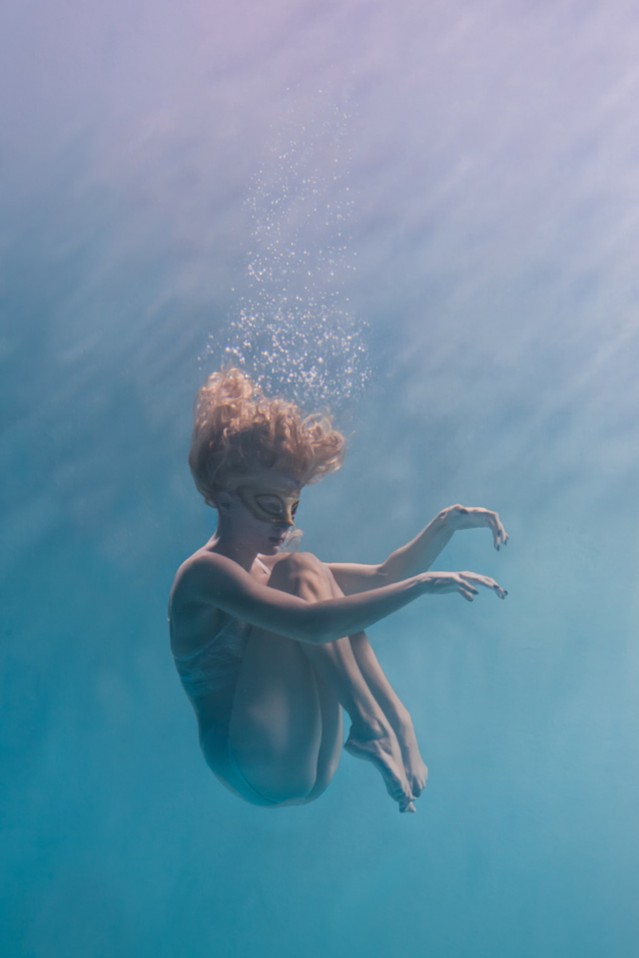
[208,94,370,411]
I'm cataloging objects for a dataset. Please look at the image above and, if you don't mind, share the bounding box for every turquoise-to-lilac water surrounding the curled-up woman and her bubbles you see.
[0,0,639,958]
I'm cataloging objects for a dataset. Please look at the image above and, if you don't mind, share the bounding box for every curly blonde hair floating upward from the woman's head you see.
[189,368,345,506]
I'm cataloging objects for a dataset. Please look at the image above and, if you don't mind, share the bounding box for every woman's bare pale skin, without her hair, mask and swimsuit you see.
[169,484,508,812]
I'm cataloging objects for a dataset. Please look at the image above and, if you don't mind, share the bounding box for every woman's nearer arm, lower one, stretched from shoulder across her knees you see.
[174,553,505,645]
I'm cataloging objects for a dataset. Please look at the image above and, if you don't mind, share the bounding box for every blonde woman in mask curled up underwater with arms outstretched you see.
[169,369,508,812]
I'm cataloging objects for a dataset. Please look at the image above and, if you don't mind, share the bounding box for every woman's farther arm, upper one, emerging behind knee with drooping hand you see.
[330,504,508,595]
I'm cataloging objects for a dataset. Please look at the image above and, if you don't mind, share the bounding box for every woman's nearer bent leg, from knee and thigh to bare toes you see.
[228,554,414,811]
